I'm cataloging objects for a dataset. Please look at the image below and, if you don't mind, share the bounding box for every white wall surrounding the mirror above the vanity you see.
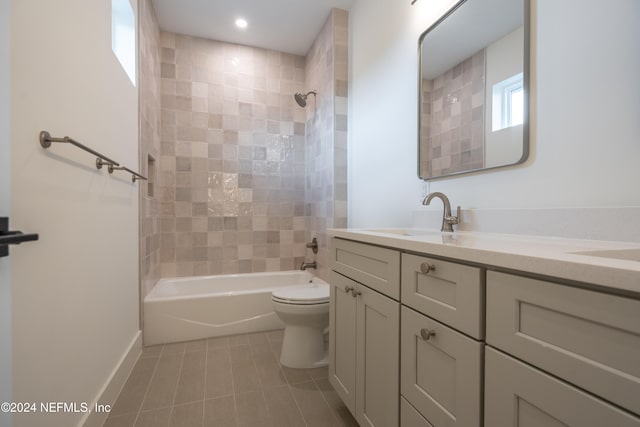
[349,0,640,227]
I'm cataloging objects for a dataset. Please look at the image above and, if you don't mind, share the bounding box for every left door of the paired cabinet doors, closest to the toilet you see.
[329,271,358,414]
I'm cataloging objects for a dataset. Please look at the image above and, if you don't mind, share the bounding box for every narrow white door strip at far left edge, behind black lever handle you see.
[0,0,11,427]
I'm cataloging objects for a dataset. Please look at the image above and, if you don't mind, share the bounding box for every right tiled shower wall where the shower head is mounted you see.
[305,9,348,280]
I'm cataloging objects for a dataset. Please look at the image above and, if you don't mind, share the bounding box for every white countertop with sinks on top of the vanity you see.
[327,228,640,298]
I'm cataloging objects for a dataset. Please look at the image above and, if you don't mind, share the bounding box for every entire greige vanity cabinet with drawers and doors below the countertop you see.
[329,237,640,427]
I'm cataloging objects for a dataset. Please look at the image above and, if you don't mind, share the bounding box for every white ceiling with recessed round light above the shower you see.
[152,0,354,55]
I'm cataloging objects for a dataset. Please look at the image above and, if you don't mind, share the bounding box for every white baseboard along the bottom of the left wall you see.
[78,331,142,427]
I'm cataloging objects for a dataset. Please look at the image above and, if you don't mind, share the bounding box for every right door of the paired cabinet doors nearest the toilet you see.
[356,285,400,427]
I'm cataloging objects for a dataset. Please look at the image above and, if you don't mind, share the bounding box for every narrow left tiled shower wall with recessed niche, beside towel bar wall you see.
[138,0,160,297]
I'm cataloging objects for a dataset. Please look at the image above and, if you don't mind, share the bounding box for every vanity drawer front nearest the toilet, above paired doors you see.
[330,238,400,300]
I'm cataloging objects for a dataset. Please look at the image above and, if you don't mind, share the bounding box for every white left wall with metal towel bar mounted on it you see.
[10,0,139,427]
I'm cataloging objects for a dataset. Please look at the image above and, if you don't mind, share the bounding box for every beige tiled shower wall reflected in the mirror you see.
[420,49,485,176]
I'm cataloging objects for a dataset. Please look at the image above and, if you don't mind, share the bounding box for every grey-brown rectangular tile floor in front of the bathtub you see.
[104,330,358,427]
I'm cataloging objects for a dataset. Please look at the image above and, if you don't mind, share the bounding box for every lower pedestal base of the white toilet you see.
[280,325,329,369]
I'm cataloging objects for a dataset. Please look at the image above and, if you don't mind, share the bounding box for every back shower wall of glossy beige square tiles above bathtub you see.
[159,32,308,277]
